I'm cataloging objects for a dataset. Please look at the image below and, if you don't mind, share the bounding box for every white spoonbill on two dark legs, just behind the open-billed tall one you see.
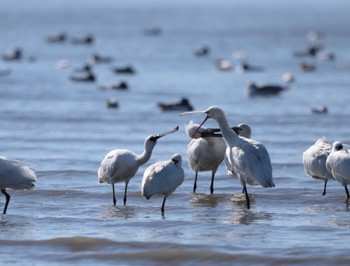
[185,121,226,194]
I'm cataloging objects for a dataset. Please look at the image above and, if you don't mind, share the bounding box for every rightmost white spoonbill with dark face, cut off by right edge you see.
[326,141,350,200]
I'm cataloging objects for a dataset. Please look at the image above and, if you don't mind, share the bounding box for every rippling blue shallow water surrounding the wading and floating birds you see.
[0,0,350,265]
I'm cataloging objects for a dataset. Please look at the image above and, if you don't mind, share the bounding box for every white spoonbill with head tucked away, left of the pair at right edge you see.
[303,137,333,195]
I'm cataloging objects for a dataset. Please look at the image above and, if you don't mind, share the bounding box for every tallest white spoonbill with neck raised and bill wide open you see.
[183,106,275,209]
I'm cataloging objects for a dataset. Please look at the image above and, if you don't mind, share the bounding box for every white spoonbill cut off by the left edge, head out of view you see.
[0,156,36,214]
